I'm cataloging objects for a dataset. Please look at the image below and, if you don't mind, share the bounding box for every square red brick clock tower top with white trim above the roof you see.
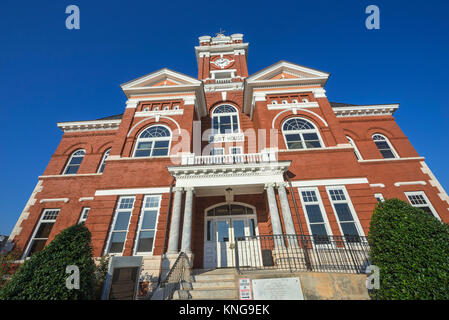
[195,31,248,91]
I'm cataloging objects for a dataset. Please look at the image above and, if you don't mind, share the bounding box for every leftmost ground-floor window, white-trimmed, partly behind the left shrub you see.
[24,209,60,258]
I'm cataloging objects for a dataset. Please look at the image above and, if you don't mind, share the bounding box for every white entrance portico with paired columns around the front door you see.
[167,154,296,268]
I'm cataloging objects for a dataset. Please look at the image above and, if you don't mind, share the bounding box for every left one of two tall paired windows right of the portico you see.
[299,188,332,244]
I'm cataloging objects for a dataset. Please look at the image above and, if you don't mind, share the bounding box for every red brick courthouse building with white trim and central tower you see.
[10,34,449,290]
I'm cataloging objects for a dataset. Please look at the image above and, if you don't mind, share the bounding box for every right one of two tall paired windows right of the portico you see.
[326,187,363,242]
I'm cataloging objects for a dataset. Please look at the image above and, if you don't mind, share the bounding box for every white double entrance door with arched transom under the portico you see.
[204,205,260,269]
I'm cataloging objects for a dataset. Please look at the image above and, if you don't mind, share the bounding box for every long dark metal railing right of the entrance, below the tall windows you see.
[234,235,370,273]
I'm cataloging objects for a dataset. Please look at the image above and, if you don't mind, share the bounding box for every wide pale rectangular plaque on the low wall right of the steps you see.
[252,277,304,300]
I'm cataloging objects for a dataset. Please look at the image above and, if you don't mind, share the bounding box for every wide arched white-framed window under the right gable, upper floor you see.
[282,118,322,150]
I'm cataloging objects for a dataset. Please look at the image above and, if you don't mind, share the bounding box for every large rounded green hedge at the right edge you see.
[368,199,449,300]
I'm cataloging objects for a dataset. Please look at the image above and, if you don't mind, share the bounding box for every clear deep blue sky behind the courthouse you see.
[0,0,449,234]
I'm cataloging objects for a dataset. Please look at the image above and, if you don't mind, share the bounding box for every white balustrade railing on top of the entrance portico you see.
[181,150,276,165]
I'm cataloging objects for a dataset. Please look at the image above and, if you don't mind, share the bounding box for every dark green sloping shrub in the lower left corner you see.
[0,225,95,300]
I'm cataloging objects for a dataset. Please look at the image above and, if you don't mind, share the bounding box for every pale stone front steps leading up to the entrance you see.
[173,269,238,300]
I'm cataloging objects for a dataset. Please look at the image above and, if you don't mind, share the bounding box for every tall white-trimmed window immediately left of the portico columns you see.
[134,195,161,254]
